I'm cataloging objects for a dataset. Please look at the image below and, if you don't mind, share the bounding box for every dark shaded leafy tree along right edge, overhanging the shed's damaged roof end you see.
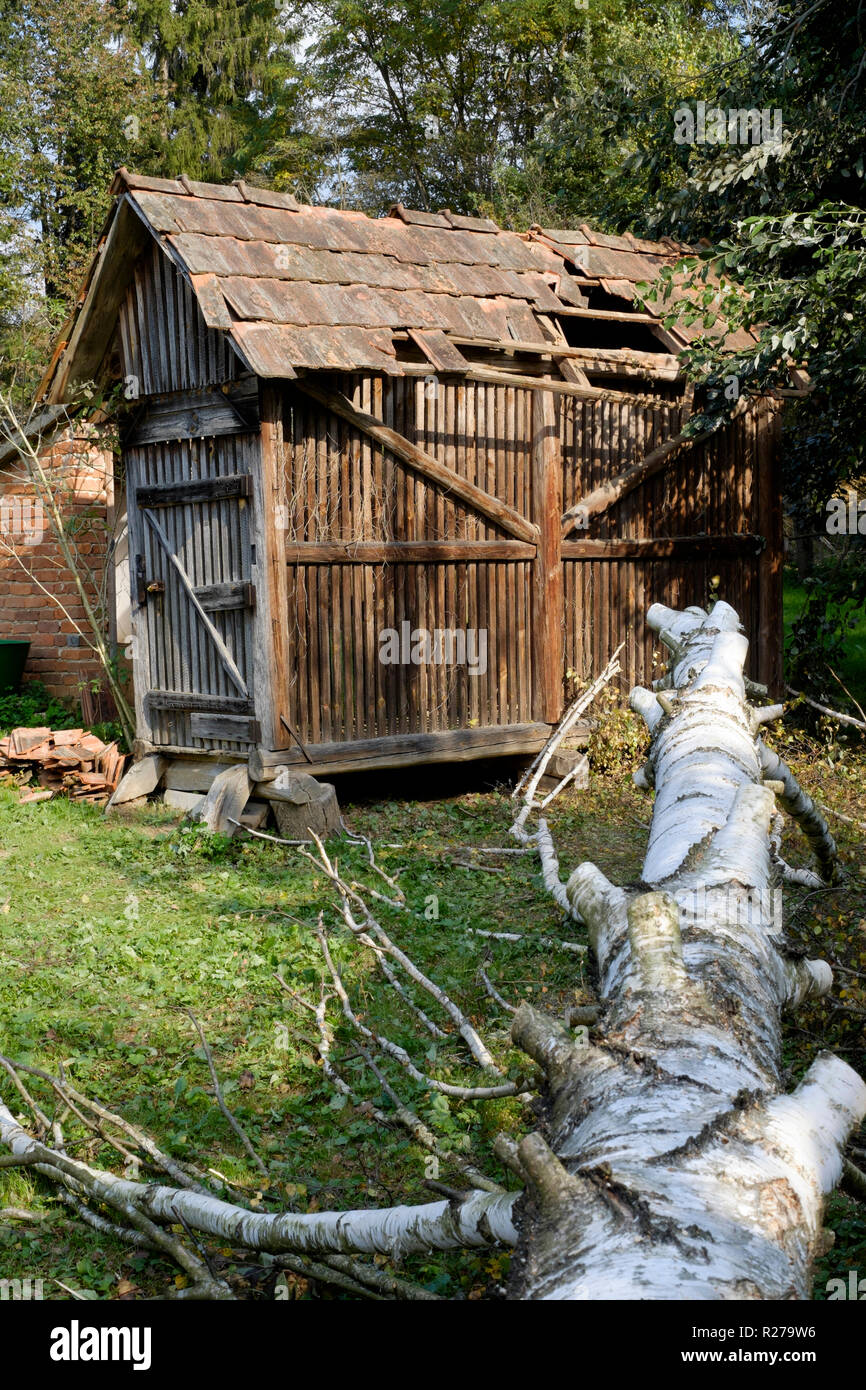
[625,0,866,703]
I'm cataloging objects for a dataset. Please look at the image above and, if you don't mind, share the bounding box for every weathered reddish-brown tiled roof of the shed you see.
[42,168,750,389]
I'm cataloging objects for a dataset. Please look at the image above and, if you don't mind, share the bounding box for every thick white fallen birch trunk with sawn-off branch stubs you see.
[512,603,866,1300]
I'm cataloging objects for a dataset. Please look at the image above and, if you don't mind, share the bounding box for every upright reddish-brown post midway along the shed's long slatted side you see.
[532,391,564,724]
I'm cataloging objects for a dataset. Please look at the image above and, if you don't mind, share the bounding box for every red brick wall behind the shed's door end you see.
[0,425,114,703]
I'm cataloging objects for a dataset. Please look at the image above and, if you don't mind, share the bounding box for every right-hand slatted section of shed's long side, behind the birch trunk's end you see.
[560,400,767,691]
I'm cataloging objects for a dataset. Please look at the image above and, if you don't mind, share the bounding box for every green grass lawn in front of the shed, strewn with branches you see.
[0,735,866,1300]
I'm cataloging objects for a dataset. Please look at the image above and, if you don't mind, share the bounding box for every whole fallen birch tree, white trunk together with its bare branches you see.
[0,602,866,1301]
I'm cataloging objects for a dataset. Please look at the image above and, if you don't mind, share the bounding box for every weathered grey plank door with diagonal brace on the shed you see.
[124,397,260,752]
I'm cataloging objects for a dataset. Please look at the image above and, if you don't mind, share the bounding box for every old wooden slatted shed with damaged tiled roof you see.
[35,170,781,773]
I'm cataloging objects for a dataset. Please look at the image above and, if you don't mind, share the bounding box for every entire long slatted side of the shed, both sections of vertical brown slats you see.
[281,374,777,744]
